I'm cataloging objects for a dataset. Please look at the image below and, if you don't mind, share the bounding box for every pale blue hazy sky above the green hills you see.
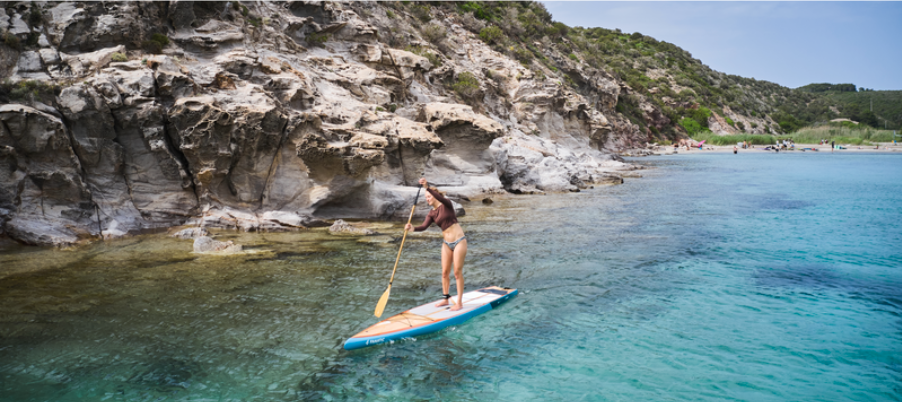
[543,1,902,90]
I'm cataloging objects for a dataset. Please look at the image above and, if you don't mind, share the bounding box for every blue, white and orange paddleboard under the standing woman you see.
[345,286,517,350]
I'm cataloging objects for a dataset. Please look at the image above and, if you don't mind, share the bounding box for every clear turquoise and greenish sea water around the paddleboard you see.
[0,152,902,401]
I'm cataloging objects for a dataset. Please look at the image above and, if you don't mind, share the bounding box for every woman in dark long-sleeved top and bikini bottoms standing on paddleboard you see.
[404,178,467,311]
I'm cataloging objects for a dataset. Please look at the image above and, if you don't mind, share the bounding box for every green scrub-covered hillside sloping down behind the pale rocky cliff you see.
[436,2,895,139]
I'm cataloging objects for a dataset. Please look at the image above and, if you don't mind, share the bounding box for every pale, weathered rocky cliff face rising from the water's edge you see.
[0,1,644,244]
